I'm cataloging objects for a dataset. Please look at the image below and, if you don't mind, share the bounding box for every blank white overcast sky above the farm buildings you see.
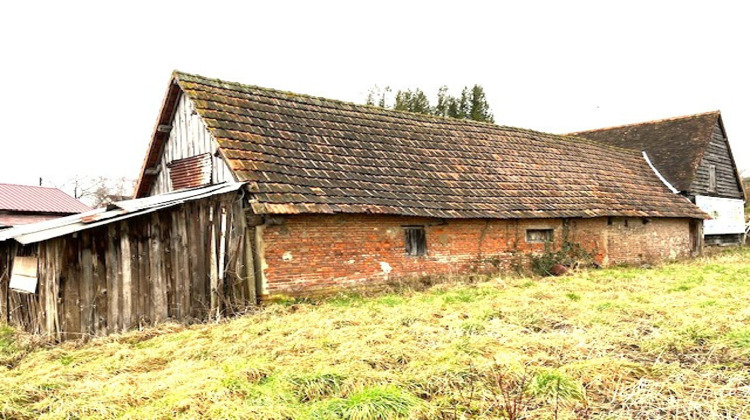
[0,0,750,194]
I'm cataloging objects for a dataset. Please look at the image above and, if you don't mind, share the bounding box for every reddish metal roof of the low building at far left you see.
[0,184,91,214]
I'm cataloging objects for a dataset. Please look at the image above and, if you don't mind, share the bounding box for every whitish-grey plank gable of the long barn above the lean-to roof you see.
[148,95,235,195]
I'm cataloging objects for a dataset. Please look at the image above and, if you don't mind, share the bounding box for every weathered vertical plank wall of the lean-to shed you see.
[0,194,256,340]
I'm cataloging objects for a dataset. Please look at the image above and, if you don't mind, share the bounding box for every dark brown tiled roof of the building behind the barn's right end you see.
[569,111,720,191]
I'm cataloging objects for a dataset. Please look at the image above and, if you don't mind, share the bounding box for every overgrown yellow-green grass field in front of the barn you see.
[0,249,750,420]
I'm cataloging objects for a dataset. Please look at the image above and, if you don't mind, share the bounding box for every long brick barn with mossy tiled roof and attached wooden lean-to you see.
[0,72,707,338]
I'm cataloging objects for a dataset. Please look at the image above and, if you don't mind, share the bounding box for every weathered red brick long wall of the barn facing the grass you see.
[261,215,690,295]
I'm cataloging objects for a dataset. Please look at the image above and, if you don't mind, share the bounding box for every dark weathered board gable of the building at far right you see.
[688,122,743,199]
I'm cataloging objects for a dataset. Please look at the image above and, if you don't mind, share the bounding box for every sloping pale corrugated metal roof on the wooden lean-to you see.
[0,182,245,245]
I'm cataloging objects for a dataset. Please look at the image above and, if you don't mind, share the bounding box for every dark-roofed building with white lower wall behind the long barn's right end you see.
[570,111,745,244]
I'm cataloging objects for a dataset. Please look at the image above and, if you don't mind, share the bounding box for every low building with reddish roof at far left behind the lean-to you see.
[0,184,91,229]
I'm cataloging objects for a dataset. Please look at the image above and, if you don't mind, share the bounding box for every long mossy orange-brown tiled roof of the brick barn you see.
[138,72,705,218]
